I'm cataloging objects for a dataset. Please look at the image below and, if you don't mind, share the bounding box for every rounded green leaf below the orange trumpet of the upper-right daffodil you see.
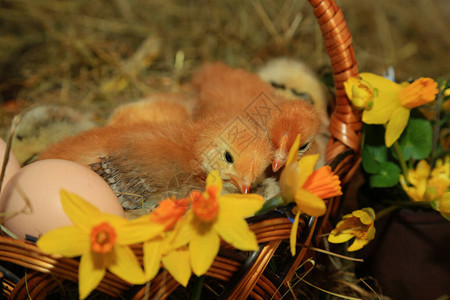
[399,118,433,160]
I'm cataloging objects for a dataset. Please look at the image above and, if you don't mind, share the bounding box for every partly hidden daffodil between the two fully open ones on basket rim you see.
[132,199,191,286]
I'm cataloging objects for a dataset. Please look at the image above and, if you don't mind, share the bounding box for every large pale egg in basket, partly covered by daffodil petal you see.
[0,159,124,239]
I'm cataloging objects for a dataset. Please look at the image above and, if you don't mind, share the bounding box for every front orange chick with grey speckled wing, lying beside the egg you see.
[39,119,273,214]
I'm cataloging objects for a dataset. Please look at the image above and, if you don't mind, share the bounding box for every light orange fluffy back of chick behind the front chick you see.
[107,92,194,126]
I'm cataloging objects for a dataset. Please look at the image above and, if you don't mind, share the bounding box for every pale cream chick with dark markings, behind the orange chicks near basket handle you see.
[258,58,330,163]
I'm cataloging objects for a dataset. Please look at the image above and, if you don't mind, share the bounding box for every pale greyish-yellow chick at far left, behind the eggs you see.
[12,105,96,165]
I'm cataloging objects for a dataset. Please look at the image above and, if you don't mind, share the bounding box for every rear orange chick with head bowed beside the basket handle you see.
[192,63,321,172]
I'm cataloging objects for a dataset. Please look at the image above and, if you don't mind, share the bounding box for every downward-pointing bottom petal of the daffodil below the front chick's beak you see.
[189,229,220,276]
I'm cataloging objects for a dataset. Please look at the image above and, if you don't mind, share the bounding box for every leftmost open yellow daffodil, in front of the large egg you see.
[37,190,164,299]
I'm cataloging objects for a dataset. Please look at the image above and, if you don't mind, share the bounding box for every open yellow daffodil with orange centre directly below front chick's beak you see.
[171,171,264,276]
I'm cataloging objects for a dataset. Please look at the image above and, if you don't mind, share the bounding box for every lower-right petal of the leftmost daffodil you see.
[108,246,145,284]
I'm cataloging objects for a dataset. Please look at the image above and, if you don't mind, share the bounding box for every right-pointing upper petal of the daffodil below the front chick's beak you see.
[219,194,264,218]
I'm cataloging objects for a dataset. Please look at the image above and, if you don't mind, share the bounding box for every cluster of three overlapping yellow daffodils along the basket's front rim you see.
[37,171,264,299]
